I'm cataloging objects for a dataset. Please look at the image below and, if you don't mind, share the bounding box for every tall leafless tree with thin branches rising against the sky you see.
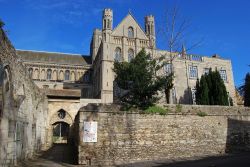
[160,5,202,103]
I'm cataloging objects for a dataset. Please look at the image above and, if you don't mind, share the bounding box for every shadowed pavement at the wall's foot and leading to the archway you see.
[18,144,250,167]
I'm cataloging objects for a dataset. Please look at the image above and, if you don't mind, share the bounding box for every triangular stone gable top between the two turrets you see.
[112,13,148,40]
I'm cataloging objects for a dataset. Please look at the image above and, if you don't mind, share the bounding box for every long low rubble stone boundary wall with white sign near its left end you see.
[75,105,250,166]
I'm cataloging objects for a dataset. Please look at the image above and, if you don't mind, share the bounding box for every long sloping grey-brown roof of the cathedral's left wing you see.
[16,50,91,65]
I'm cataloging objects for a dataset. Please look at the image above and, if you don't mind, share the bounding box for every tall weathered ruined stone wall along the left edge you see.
[0,27,47,166]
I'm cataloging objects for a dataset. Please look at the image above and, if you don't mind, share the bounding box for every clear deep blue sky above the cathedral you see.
[0,0,250,86]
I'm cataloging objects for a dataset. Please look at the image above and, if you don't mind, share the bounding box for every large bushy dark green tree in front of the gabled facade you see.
[114,49,172,107]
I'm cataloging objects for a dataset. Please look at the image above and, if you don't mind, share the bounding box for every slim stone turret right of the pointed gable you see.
[145,15,155,48]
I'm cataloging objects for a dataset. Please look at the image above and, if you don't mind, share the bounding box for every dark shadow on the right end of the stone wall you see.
[225,118,250,153]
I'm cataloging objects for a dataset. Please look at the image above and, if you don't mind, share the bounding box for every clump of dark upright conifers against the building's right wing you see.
[196,69,229,105]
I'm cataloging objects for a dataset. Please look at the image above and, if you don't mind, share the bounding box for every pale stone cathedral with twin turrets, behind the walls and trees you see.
[17,9,235,104]
